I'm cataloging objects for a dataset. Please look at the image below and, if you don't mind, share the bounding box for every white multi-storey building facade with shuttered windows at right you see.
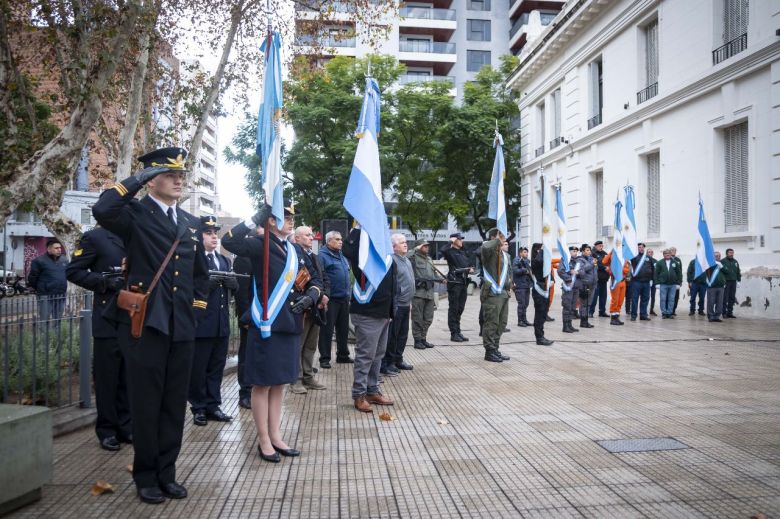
[508,0,780,317]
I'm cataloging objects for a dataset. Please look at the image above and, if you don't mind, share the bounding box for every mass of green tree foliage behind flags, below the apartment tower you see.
[225,56,520,236]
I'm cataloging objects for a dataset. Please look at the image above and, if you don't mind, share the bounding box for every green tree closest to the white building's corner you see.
[440,56,520,239]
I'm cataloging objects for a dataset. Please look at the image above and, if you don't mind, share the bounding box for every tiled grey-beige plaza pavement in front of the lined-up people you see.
[7,295,780,519]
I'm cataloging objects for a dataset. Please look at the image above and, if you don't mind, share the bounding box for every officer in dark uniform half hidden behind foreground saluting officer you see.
[65,227,133,451]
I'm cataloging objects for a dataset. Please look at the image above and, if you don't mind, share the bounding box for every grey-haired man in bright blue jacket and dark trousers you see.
[318,231,352,369]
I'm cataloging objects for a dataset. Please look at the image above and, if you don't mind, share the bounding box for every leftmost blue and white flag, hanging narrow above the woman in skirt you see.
[255,32,284,229]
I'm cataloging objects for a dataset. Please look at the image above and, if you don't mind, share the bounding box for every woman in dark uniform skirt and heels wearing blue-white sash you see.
[222,204,322,463]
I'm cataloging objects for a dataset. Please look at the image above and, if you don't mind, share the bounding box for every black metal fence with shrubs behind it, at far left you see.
[0,289,239,408]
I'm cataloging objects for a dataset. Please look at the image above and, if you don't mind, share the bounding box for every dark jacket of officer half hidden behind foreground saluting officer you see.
[65,227,125,339]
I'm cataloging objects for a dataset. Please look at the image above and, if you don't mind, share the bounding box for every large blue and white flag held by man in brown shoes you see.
[344,77,392,287]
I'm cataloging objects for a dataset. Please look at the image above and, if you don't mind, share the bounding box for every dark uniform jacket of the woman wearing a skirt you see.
[222,222,322,334]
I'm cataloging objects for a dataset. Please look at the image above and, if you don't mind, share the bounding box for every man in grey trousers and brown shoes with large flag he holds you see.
[344,75,396,413]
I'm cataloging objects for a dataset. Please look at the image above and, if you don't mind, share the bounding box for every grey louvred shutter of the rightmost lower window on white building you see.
[724,122,749,232]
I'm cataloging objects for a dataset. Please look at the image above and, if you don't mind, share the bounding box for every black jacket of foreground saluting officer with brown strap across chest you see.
[92,177,208,341]
